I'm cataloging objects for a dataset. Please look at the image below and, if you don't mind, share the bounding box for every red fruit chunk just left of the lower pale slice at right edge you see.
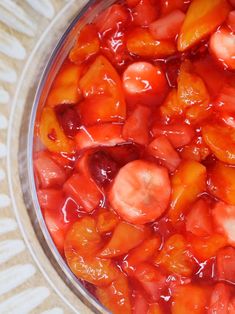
[186,199,213,237]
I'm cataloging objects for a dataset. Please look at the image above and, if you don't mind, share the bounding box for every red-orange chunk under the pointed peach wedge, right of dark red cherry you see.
[77,95,125,126]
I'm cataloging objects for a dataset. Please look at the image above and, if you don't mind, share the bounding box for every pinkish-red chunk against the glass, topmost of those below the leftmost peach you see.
[34,151,66,189]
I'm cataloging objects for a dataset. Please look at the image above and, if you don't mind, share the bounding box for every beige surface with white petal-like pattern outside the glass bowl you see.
[0,0,93,314]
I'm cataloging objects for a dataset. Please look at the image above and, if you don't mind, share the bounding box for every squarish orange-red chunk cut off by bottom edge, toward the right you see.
[171,284,211,314]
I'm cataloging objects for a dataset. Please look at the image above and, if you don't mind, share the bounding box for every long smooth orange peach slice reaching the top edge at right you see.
[178,0,230,51]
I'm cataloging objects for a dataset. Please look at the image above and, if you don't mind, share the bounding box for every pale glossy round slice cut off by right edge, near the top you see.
[210,28,235,70]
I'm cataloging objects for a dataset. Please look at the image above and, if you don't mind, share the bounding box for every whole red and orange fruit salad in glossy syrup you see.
[33,0,235,314]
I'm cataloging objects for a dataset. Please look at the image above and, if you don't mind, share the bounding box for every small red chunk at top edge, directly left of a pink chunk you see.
[131,0,159,26]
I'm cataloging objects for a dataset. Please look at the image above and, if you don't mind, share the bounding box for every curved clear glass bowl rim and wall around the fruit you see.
[14,0,115,313]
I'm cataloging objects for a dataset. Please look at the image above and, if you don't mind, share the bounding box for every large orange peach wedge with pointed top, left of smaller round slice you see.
[79,55,126,119]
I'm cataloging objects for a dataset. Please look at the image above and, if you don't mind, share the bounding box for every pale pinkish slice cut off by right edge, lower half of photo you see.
[212,202,235,245]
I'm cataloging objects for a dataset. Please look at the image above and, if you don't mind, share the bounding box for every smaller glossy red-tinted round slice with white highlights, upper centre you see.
[123,62,166,106]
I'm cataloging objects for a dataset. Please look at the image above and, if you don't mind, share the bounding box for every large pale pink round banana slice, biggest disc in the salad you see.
[109,160,171,224]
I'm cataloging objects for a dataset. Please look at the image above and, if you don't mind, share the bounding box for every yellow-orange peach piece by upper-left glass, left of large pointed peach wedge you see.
[46,63,81,107]
